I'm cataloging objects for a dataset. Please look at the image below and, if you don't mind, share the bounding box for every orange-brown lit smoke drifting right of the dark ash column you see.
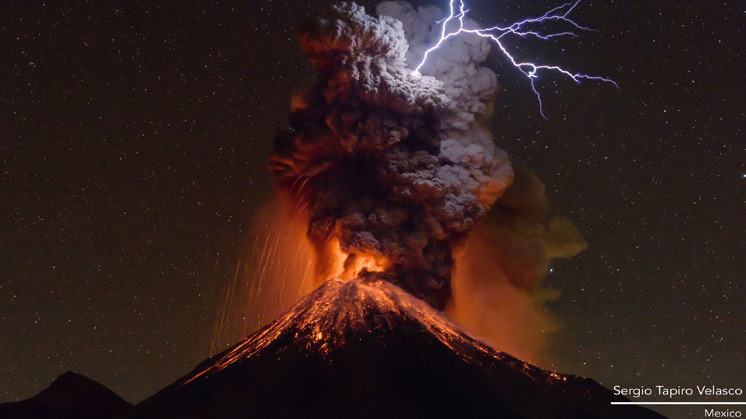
[446,168,587,365]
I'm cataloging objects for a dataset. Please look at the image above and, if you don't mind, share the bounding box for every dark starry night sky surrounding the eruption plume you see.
[0,0,746,414]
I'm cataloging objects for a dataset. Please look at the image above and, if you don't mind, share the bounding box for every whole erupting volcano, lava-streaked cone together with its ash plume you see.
[125,2,657,418]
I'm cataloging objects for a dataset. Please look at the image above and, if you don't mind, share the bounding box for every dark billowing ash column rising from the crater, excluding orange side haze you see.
[270,2,512,309]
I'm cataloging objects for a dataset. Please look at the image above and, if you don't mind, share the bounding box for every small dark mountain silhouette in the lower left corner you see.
[0,371,132,419]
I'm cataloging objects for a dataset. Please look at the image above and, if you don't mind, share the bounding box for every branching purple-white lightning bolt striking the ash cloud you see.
[414,0,619,119]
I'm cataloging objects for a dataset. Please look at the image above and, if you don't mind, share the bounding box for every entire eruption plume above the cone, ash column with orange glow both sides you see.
[216,2,586,362]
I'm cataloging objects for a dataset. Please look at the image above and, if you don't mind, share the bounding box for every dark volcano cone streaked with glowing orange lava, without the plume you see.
[128,275,661,419]
